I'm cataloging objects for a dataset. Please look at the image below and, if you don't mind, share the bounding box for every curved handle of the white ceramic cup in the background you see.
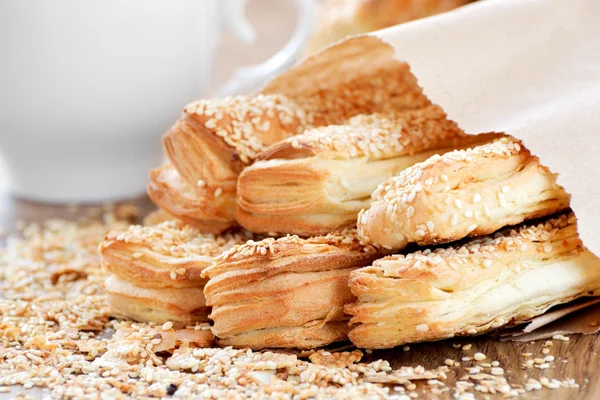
[217,0,316,97]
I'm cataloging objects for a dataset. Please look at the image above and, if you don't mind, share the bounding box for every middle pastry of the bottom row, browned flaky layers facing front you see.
[204,230,381,349]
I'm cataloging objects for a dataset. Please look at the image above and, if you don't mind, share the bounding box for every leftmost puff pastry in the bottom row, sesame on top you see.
[99,221,250,324]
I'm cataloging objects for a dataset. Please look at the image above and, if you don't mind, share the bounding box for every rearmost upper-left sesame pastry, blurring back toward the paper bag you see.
[148,48,429,233]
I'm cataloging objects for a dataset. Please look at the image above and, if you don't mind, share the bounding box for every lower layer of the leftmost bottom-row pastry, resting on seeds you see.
[105,275,210,325]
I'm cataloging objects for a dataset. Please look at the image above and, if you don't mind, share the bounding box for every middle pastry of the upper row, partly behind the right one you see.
[236,106,493,236]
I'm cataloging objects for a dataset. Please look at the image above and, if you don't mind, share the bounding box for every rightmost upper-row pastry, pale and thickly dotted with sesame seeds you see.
[358,137,569,249]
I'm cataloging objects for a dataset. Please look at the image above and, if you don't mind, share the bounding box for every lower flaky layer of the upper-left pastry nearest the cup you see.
[147,164,236,233]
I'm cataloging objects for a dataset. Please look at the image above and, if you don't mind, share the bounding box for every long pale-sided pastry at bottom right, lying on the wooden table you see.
[345,214,600,349]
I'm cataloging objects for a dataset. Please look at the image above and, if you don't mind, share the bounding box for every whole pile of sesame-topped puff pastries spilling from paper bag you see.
[100,54,600,349]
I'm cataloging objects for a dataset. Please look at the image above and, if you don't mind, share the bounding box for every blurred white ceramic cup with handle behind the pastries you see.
[0,0,315,202]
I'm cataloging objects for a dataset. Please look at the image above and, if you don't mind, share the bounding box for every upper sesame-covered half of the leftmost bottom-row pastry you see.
[99,221,249,288]
